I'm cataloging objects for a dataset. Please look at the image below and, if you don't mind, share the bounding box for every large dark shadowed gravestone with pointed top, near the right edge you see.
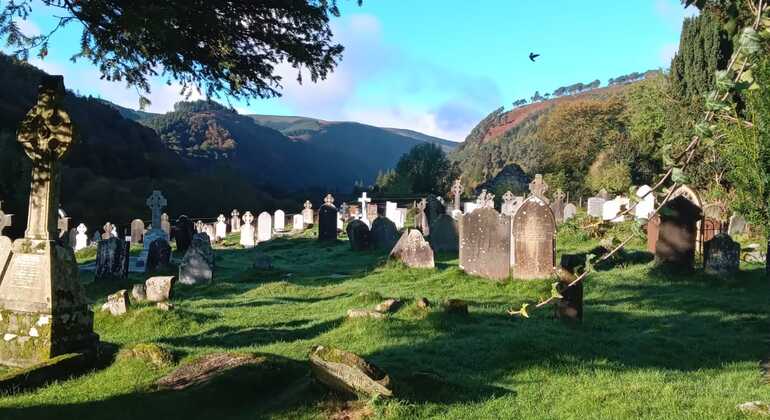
[655,195,703,271]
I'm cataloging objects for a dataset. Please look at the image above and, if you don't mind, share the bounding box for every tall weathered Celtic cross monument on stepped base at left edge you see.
[0,76,99,366]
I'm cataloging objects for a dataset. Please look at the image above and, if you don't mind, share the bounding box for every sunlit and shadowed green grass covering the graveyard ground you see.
[0,223,770,420]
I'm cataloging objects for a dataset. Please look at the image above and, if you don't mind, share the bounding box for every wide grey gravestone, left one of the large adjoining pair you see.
[460,207,511,280]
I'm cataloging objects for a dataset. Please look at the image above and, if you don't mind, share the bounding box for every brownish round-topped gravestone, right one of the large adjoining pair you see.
[511,195,556,279]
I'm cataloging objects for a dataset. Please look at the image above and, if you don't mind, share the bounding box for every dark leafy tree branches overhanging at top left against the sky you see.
[0,0,361,106]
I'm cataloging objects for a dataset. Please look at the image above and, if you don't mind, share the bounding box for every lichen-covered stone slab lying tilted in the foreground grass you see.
[308,346,393,397]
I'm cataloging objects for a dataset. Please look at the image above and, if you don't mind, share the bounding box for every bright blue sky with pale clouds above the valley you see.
[6,0,697,141]
